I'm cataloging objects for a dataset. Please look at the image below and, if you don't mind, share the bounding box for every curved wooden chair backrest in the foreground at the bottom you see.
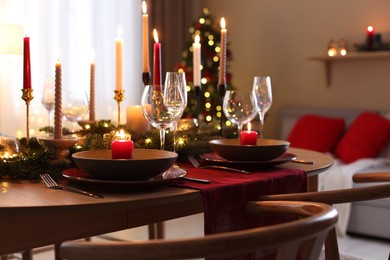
[60,201,337,260]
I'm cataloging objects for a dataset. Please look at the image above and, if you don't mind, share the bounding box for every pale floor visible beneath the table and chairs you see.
[6,214,390,260]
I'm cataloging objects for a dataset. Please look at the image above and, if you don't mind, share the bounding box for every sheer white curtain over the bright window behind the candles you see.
[0,0,143,137]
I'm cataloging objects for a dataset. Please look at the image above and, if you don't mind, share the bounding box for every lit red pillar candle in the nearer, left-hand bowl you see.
[111,130,134,159]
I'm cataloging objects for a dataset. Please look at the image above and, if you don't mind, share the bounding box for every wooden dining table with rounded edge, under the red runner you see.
[0,148,333,255]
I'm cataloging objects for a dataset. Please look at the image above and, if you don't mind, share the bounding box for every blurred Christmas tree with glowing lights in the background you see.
[175,8,233,125]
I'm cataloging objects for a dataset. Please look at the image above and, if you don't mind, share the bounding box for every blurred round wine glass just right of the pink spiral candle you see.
[62,92,88,133]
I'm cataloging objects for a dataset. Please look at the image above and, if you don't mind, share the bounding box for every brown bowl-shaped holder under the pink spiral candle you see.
[37,136,79,161]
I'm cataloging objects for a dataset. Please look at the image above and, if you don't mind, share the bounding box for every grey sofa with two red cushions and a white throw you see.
[277,107,390,239]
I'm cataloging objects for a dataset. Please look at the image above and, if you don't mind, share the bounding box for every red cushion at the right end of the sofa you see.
[334,112,390,163]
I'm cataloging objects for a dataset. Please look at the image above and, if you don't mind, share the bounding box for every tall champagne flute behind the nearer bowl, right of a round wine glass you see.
[164,72,187,174]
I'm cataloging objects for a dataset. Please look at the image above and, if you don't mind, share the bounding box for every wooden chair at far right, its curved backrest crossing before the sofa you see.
[259,172,390,260]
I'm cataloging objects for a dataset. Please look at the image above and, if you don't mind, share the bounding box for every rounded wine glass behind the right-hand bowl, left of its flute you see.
[223,90,257,136]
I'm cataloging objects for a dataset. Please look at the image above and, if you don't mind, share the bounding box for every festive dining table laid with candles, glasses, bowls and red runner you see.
[0,1,333,254]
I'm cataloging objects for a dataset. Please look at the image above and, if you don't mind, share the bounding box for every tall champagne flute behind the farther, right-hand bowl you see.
[252,76,272,138]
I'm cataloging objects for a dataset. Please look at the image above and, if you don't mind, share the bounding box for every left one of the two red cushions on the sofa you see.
[288,114,345,153]
